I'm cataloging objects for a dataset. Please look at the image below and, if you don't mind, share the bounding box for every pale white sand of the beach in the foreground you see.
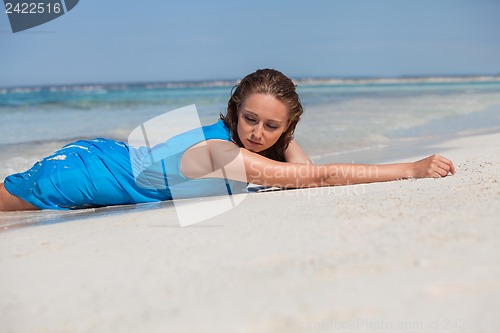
[0,134,500,333]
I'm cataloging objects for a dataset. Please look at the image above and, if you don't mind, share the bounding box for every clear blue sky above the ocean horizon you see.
[0,0,500,87]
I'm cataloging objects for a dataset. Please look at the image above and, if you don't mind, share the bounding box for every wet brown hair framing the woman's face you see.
[220,68,304,162]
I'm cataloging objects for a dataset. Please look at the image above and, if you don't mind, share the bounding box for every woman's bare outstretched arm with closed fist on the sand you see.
[181,140,455,188]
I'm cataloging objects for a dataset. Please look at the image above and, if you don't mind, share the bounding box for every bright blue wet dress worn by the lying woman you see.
[5,120,246,209]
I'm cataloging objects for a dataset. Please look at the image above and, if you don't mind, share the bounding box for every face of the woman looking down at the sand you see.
[238,94,289,153]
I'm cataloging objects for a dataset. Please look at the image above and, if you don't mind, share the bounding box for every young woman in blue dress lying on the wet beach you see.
[0,69,455,211]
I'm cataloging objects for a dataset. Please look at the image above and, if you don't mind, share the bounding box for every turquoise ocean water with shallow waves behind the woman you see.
[0,77,500,179]
